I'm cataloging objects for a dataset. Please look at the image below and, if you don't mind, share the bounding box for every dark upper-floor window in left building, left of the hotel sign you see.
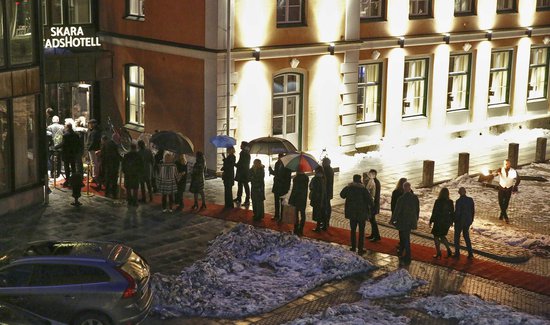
[6,0,33,65]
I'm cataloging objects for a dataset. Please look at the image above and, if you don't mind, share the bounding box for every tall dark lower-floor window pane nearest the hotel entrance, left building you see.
[13,96,39,189]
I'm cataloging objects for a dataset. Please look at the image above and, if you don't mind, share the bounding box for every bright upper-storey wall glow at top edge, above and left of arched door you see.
[235,0,275,47]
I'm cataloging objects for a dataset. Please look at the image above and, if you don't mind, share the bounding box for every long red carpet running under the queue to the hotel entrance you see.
[58,180,550,296]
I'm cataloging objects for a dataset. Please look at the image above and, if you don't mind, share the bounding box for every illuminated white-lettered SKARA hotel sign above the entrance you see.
[44,26,101,48]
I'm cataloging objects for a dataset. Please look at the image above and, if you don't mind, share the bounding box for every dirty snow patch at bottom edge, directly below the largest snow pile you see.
[285,300,409,325]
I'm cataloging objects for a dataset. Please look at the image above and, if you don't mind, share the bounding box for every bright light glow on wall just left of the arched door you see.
[235,61,272,141]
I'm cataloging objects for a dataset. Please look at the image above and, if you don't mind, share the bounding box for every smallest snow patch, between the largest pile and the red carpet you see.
[358,269,428,298]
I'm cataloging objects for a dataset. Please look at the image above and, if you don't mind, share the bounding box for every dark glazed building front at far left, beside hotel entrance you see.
[0,0,46,214]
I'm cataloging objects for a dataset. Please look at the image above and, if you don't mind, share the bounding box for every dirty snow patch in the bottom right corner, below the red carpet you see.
[406,295,550,325]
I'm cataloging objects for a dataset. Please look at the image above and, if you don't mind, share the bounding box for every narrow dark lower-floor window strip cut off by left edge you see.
[0,100,11,194]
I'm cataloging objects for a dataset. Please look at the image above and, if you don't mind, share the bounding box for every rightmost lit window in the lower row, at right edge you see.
[527,47,550,99]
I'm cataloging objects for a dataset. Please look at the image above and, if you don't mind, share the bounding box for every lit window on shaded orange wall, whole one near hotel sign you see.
[126,65,145,126]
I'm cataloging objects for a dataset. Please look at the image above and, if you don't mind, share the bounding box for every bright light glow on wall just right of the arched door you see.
[308,55,342,150]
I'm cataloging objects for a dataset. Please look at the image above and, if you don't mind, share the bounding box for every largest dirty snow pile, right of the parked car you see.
[153,224,375,318]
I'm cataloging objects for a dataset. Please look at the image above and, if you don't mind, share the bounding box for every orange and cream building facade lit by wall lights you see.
[99,0,550,169]
